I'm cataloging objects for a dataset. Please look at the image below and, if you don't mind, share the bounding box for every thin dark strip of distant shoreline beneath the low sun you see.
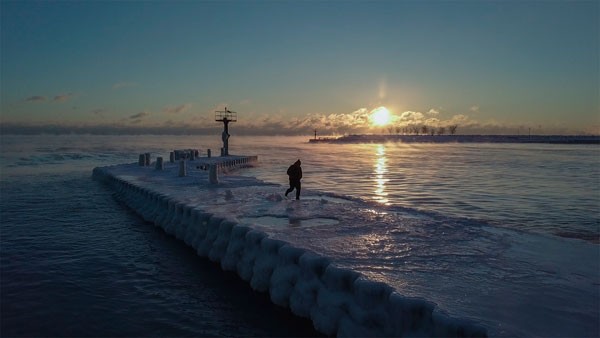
[308,135,600,144]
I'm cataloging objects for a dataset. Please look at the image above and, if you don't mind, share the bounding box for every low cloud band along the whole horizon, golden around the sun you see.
[0,113,600,135]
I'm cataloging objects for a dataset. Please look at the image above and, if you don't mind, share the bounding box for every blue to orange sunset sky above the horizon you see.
[0,0,600,135]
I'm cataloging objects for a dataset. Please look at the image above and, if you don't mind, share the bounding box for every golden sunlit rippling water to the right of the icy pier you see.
[235,135,600,242]
